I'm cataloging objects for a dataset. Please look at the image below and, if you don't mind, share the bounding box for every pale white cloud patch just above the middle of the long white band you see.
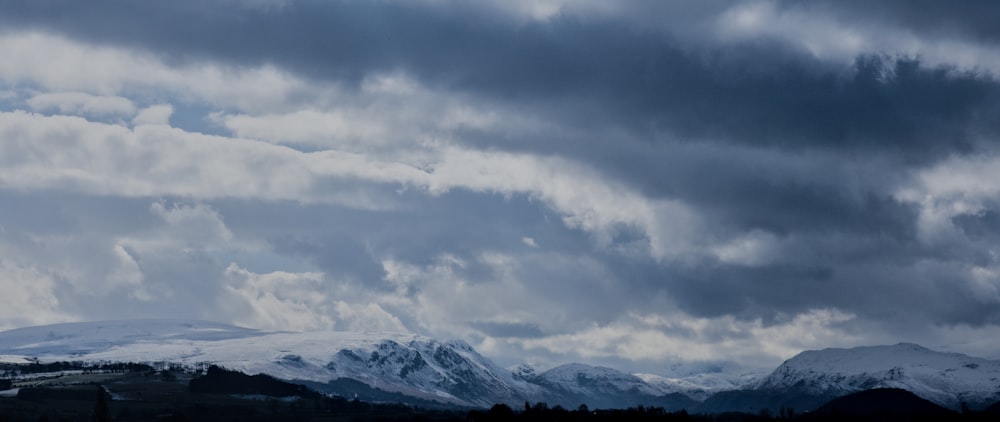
[216,72,565,155]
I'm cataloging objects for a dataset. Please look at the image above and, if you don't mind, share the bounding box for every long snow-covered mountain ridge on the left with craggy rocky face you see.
[0,320,690,407]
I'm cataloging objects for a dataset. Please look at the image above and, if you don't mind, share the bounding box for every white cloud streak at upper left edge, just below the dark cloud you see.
[0,32,329,111]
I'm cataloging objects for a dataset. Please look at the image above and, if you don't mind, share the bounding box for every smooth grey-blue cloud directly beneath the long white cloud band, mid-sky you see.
[216,191,590,287]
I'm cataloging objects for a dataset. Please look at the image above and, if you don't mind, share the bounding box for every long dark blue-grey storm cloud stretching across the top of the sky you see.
[0,0,1000,162]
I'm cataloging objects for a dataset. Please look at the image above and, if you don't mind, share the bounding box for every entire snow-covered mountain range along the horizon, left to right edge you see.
[0,320,1000,413]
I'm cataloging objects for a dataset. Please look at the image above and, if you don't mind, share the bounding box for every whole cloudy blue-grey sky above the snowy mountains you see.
[0,0,1000,375]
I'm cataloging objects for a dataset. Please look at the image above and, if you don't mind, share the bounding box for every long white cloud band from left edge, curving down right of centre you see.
[0,102,712,258]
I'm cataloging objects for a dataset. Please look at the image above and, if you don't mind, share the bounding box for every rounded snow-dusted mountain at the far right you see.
[751,343,1000,408]
